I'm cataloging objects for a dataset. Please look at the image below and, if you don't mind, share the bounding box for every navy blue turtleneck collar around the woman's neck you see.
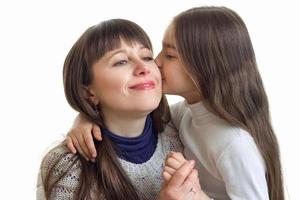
[101,115,157,164]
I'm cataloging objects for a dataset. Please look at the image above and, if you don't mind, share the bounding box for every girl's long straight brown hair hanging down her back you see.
[173,7,284,200]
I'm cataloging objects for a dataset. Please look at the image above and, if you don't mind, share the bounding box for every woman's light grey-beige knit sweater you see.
[37,124,183,200]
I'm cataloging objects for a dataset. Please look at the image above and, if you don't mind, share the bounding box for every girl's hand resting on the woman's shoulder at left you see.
[66,114,102,161]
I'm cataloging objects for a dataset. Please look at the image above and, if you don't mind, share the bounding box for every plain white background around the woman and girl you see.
[0,0,300,200]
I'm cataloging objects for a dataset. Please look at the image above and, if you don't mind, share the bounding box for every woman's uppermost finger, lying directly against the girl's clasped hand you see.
[169,160,195,187]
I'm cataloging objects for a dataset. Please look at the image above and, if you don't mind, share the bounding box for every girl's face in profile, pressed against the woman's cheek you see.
[155,24,199,102]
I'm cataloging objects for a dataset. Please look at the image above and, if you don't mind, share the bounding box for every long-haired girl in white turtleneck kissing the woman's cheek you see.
[68,7,284,200]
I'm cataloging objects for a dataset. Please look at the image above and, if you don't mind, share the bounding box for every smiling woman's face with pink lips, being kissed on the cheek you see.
[88,40,162,115]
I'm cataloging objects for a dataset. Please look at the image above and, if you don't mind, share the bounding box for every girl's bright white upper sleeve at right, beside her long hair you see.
[217,136,269,200]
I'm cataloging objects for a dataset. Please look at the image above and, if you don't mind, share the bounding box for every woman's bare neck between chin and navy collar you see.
[103,112,147,138]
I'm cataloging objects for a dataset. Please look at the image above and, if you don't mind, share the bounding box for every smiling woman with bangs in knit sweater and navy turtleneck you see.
[37,19,206,200]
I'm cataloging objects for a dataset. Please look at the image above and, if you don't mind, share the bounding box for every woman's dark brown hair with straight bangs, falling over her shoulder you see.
[43,19,169,200]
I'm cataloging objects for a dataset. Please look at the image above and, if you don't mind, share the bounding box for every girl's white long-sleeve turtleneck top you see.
[170,101,269,200]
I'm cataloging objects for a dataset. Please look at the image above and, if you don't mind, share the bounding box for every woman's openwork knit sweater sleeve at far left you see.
[36,146,81,200]
